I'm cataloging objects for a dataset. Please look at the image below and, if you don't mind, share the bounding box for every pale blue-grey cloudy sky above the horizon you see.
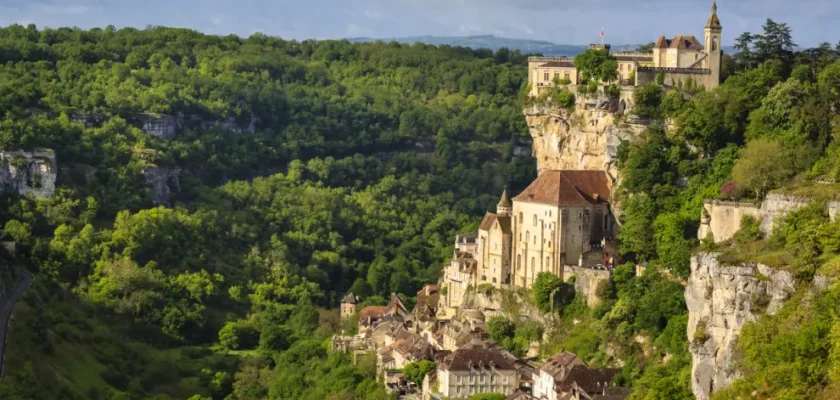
[0,0,840,46]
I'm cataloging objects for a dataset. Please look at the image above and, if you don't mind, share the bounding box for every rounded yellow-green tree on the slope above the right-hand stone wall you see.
[732,138,791,199]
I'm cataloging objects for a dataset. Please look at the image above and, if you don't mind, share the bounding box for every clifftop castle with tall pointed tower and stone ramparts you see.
[528,3,723,95]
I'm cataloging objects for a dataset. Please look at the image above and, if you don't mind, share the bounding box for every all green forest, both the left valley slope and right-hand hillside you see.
[0,20,840,400]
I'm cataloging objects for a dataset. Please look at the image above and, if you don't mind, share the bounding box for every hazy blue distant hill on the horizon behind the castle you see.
[348,35,735,56]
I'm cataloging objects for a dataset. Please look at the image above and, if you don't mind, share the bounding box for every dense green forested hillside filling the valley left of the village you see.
[0,26,535,400]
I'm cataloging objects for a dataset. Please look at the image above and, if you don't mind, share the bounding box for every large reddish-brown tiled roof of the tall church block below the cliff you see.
[513,171,611,206]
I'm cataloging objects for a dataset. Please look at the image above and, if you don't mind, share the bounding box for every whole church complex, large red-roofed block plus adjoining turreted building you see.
[474,170,617,288]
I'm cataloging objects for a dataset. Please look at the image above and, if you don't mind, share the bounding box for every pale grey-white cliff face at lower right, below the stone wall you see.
[685,253,796,400]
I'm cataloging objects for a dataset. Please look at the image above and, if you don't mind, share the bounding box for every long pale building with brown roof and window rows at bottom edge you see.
[430,348,519,399]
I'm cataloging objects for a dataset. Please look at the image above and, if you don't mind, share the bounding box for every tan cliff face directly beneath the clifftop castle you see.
[524,92,645,178]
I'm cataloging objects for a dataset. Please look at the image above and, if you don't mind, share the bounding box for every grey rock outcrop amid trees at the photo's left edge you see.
[0,149,58,197]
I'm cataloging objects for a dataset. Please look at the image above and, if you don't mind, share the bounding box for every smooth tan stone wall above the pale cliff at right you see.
[697,200,762,243]
